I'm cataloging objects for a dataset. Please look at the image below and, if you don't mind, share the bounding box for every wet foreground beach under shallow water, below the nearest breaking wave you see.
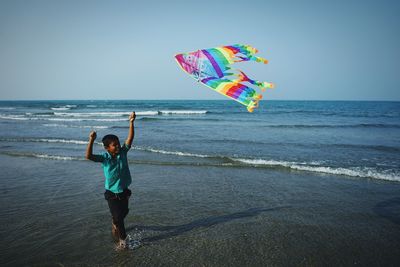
[0,156,400,266]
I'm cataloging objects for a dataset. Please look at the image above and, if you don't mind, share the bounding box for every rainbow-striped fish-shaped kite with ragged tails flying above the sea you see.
[175,44,274,112]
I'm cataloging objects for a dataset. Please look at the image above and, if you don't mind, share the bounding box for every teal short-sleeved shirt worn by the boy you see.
[95,143,132,193]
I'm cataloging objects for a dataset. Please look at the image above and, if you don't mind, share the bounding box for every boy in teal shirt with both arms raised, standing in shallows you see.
[86,112,136,249]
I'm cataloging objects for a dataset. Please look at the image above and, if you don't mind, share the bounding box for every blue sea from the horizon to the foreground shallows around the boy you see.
[0,100,400,266]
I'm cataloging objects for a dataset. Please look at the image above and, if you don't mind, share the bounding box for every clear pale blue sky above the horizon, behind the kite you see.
[0,0,400,101]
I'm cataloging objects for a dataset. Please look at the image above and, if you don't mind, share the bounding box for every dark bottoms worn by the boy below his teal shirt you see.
[104,189,132,239]
